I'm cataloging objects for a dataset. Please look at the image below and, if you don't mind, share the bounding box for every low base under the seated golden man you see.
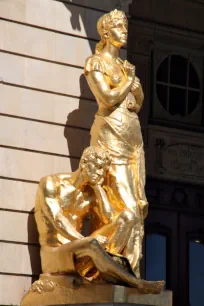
[21,274,172,306]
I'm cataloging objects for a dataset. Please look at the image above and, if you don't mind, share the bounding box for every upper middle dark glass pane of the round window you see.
[170,55,188,86]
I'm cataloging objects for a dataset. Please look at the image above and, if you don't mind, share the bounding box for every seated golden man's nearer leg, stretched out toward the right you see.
[42,237,163,293]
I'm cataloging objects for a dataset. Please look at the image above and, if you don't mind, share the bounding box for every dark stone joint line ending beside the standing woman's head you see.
[0,16,98,42]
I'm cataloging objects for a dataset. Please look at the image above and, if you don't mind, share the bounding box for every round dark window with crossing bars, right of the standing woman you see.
[156,55,200,117]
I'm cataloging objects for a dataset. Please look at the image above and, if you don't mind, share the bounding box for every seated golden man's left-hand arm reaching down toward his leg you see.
[40,176,84,240]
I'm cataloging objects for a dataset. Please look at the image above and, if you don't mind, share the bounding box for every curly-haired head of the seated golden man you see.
[80,146,111,185]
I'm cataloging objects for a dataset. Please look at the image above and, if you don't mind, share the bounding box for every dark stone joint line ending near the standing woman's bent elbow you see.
[0,80,95,102]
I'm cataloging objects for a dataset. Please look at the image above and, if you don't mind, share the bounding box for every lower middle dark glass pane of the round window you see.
[169,87,186,117]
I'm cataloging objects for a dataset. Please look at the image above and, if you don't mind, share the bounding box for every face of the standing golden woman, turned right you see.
[108,19,128,47]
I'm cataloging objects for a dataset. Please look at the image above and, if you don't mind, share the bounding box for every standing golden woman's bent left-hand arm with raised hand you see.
[86,59,135,108]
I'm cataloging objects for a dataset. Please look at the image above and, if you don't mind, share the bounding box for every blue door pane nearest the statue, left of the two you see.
[146,234,167,281]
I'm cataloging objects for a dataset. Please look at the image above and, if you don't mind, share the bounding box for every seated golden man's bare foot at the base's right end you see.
[136,279,165,294]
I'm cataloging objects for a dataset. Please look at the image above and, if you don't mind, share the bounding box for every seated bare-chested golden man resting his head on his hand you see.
[35,147,163,293]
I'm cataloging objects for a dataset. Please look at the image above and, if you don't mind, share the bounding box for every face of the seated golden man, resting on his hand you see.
[83,158,105,185]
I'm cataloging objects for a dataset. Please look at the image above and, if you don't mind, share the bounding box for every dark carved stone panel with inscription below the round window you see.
[147,125,204,185]
